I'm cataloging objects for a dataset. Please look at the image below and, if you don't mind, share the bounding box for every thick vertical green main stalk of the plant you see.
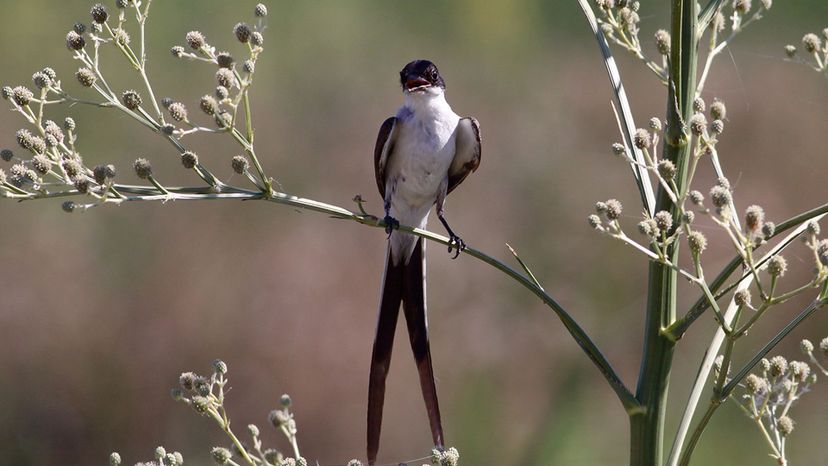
[630,0,698,466]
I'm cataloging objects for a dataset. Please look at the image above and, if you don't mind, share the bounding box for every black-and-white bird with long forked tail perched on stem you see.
[367,60,481,466]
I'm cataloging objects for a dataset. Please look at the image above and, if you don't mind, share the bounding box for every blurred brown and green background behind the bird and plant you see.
[0,0,828,465]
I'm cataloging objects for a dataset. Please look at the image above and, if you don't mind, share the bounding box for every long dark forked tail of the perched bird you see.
[368,239,443,466]
